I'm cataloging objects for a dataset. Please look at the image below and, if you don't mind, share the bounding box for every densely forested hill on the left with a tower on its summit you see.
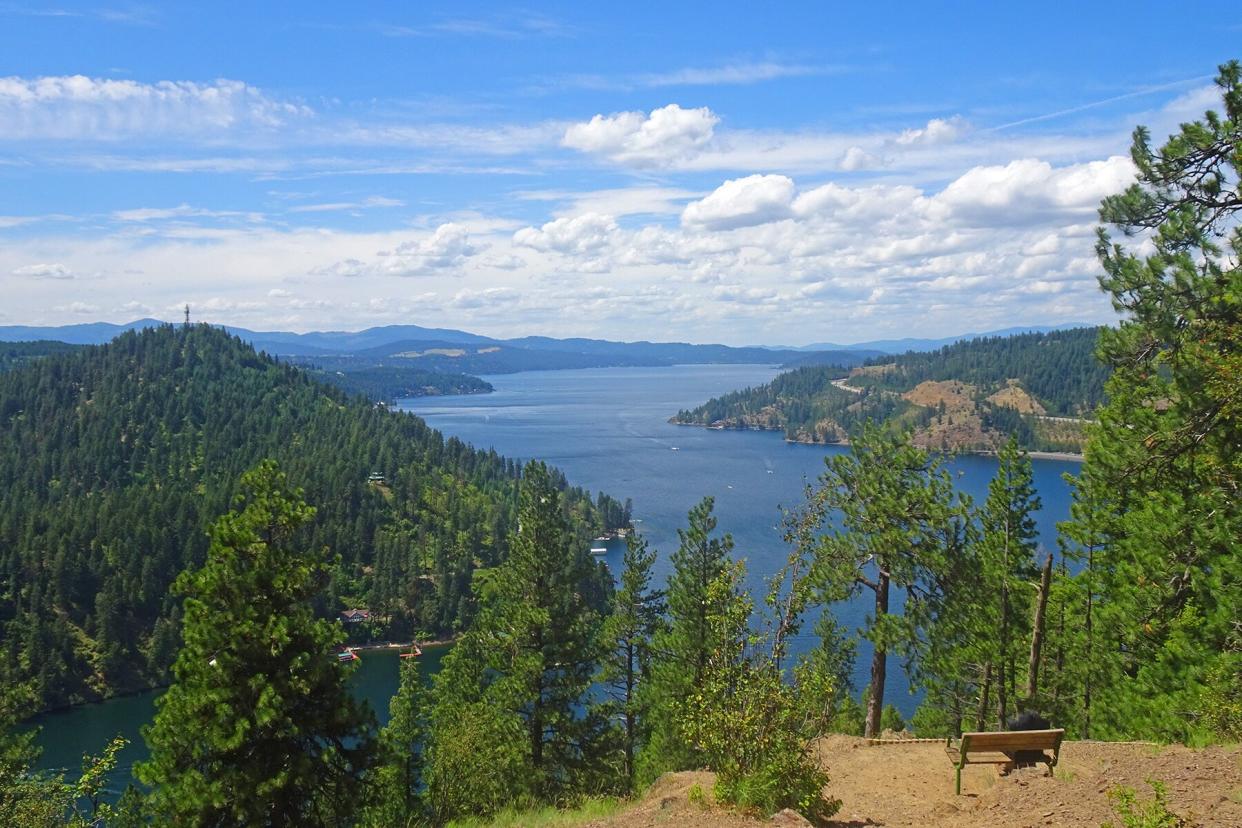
[0,325,627,705]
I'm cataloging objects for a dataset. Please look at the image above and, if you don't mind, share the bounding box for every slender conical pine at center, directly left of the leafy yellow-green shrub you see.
[638,498,733,783]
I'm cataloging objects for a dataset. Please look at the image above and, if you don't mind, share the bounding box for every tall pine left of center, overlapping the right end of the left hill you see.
[428,463,607,818]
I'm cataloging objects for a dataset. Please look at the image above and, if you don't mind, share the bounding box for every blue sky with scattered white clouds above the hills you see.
[0,0,1242,344]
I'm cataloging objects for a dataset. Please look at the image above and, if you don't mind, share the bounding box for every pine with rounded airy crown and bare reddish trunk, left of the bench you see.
[812,425,961,736]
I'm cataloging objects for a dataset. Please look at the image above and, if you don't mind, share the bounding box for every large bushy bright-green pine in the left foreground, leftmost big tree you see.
[135,461,375,826]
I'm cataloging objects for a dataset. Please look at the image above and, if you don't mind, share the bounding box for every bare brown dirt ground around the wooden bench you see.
[591,736,1242,828]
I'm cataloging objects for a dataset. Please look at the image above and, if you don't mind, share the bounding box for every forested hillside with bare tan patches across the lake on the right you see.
[674,328,1108,452]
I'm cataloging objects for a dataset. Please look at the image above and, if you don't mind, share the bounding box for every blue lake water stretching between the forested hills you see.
[36,365,1078,787]
